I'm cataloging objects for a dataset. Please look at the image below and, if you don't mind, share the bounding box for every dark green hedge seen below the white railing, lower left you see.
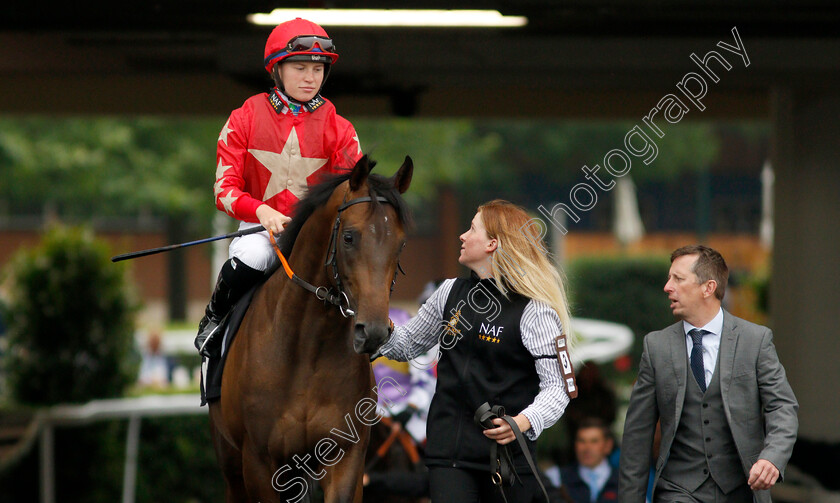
[0,412,224,503]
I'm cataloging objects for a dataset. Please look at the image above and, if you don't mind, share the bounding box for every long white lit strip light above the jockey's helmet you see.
[248,9,528,28]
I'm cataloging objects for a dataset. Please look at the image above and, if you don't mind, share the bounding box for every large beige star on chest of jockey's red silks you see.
[248,127,327,201]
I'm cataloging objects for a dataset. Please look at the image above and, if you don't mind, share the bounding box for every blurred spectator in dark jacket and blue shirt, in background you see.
[560,418,618,503]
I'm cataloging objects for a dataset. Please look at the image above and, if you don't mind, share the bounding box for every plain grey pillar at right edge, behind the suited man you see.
[770,86,840,442]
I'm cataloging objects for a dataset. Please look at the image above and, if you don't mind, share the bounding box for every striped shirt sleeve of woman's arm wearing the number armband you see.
[519,300,569,440]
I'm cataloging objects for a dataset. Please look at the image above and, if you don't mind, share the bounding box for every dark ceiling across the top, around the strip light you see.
[0,0,840,117]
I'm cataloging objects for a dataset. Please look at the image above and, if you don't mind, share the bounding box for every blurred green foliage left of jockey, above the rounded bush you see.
[0,117,222,232]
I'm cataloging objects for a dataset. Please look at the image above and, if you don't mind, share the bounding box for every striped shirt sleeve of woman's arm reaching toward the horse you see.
[379,279,455,362]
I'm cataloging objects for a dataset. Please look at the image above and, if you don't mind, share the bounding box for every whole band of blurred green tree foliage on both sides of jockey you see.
[0,117,732,232]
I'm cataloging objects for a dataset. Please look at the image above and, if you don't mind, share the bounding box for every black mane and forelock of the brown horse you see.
[280,156,411,256]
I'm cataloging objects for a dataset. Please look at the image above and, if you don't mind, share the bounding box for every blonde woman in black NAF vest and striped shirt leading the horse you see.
[380,200,570,503]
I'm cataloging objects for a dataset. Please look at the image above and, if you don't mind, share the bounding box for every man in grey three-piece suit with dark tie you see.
[619,245,799,503]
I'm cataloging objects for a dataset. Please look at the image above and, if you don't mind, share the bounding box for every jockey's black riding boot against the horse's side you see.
[195,258,264,358]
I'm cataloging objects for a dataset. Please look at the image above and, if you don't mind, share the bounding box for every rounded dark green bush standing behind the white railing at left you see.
[4,227,137,405]
